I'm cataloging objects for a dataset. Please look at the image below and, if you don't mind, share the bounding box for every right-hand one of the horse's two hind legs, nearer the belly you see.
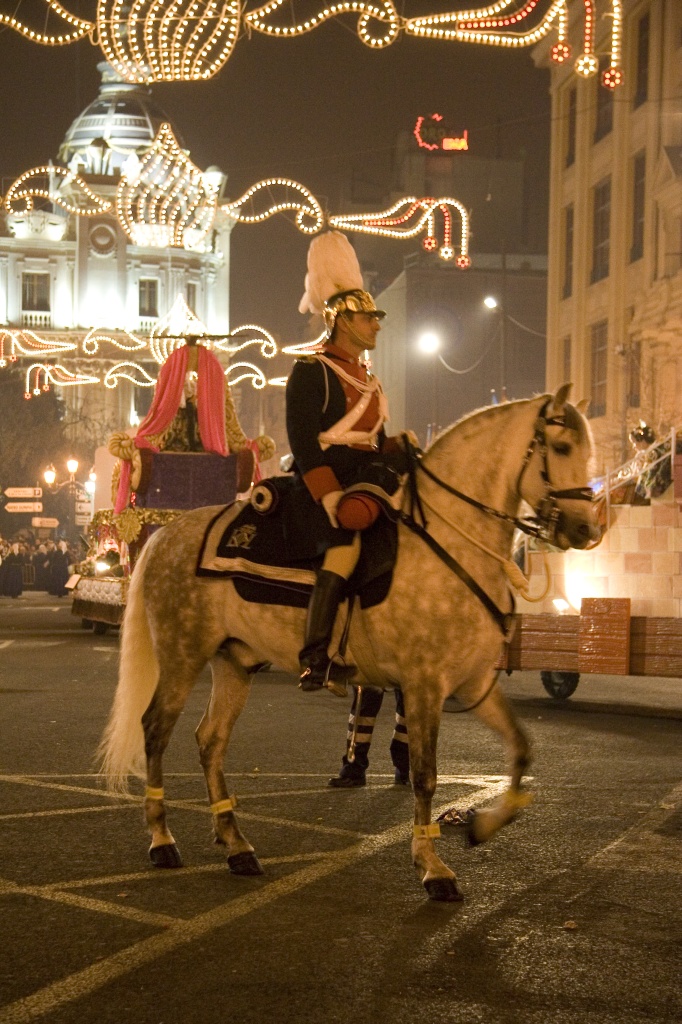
[197,651,263,874]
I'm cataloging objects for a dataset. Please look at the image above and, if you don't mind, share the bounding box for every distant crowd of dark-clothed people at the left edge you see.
[0,537,80,597]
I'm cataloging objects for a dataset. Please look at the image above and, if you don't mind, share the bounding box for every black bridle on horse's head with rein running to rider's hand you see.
[414,399,593,544]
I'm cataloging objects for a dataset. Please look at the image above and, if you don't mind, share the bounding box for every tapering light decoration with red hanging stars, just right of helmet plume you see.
[328,196,469,266]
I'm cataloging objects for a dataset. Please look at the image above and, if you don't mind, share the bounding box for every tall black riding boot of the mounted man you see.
[298,569,355,690]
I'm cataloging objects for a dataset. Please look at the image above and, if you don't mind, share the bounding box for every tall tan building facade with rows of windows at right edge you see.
[535,0,682,470]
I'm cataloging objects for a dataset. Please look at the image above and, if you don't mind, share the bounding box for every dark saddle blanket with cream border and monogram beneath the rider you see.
[197,477,397,607]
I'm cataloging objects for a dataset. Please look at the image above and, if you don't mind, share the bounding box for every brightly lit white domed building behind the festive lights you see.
[0,63,235,447]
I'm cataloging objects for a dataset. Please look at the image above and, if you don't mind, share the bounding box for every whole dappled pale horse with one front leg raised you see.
[101,385,598,900]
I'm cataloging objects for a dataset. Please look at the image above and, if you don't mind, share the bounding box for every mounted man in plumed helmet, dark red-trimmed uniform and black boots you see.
[287,231,404,692]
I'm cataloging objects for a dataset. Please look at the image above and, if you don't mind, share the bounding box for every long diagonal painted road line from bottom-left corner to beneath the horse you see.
[0,779,503,1024]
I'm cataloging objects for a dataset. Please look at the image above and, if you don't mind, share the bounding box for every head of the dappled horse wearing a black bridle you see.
[519,384,601,550]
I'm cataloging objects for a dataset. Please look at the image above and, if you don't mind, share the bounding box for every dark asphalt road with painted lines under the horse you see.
[0,595,682,1024]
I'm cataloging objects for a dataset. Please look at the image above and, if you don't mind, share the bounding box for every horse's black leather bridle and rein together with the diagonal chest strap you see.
[399,399,593,639]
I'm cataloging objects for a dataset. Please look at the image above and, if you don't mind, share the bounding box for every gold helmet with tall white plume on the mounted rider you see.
[298,231,386,338]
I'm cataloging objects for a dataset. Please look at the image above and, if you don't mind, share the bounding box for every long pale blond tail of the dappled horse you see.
[97,542,159,793]
